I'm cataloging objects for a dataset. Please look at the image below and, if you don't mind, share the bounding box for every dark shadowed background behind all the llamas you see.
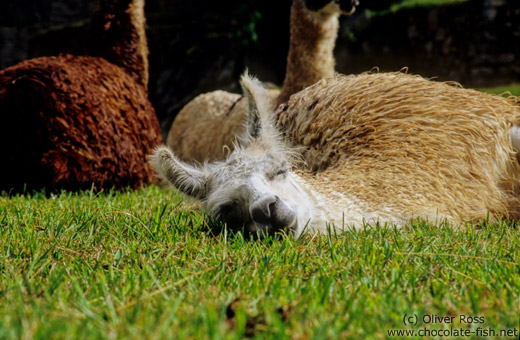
[0,0,520,133]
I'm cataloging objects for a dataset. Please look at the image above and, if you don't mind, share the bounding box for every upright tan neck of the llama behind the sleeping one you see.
[276,0,339,105]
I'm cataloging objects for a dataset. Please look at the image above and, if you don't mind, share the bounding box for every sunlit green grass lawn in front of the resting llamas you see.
[0,186,520,339]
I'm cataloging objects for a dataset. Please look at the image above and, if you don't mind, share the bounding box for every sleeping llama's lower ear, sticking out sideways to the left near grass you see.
[150,146,206,199]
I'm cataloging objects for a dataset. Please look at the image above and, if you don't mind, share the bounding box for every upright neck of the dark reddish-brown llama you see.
[91,0,148,88]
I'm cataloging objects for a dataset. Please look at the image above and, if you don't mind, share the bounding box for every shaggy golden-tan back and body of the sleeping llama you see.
[277,73,520,222]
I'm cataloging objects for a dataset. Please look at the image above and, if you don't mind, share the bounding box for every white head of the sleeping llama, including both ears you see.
[151,74,311,235]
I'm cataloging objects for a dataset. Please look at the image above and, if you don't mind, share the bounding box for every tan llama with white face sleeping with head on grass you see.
[151,73,520,236]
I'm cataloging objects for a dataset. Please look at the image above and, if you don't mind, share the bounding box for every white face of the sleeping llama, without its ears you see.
[203,148,301,234]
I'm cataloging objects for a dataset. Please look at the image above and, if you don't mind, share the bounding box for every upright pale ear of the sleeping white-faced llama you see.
[240,71,269,139]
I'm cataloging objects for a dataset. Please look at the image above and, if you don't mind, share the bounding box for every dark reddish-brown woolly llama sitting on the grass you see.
[0,0,163,190]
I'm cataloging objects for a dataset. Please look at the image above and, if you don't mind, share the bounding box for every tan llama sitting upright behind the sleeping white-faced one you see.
[166,0,357,162]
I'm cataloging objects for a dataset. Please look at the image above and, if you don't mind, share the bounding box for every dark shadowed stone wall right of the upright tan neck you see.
[337,0,520,87]
